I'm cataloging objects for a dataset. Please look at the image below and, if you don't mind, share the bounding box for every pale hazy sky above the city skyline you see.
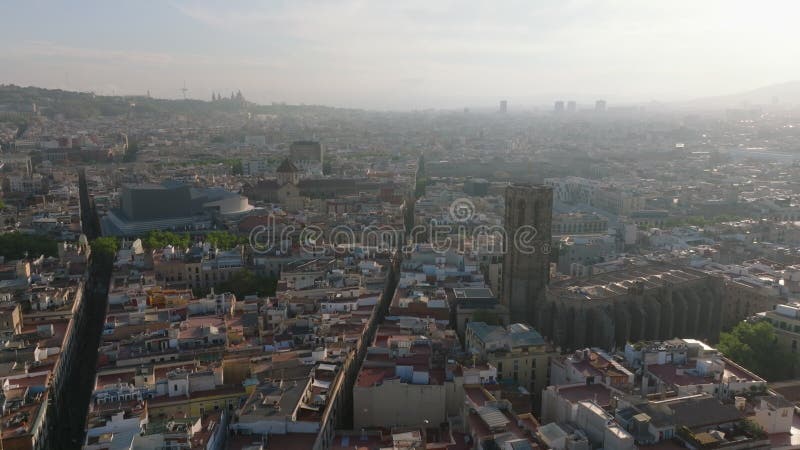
[0,0,800,109]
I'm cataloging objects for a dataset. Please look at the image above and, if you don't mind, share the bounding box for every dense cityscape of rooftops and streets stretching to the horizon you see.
[0,85,800,450]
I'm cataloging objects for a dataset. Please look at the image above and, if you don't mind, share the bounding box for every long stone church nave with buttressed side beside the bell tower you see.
[540,262,724,350]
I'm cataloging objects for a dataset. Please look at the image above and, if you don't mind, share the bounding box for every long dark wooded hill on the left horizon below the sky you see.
[0,85,354,119]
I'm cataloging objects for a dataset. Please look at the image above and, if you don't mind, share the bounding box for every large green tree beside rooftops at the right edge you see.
[717,321,798,381]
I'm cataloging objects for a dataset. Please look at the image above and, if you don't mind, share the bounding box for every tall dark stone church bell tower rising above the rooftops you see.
[502,184,553,327]
